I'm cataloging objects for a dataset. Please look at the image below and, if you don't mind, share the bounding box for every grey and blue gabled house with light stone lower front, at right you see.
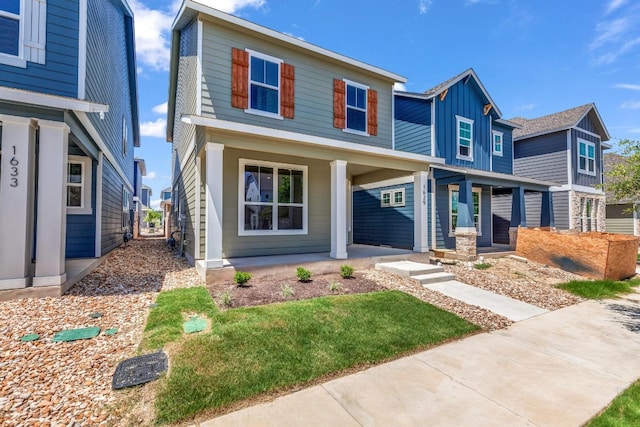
[504,104,611,231]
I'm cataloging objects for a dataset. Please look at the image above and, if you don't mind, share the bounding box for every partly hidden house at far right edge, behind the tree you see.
[604,153,640,236]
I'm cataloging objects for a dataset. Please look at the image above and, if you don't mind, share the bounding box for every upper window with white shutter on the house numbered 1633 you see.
[0,0,47,68]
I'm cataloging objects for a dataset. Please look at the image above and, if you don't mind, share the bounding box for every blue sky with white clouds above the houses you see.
[129,0,640,206]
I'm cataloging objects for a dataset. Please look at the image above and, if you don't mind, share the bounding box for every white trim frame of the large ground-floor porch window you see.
[238,159,309,236]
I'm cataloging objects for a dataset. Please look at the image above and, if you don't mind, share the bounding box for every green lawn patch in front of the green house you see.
[142,288,479,423]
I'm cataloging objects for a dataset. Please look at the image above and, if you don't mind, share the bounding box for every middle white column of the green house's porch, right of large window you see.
[329,160,347,259]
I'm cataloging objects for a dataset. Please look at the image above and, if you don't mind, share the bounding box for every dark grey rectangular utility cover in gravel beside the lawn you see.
[111,350,168,390]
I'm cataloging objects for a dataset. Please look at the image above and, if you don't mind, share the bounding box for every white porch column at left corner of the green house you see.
[206,142,224,269]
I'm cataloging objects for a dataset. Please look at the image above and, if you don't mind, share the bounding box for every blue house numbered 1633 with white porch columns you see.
[0,0,139,289]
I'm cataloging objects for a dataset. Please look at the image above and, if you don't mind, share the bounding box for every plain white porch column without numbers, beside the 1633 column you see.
[33,120,69,286]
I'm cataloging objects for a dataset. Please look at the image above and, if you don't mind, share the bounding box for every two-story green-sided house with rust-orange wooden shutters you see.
[167,0,442,275]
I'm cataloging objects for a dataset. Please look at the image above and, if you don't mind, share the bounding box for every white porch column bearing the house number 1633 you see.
[0,115,36,289]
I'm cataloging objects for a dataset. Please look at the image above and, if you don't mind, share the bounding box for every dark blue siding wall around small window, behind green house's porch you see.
[353,182,414,249]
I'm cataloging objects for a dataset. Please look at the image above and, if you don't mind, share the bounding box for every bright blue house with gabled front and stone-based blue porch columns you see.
[353,69,554,252]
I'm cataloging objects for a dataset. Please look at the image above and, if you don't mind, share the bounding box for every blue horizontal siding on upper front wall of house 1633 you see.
[0,0,79,98]
